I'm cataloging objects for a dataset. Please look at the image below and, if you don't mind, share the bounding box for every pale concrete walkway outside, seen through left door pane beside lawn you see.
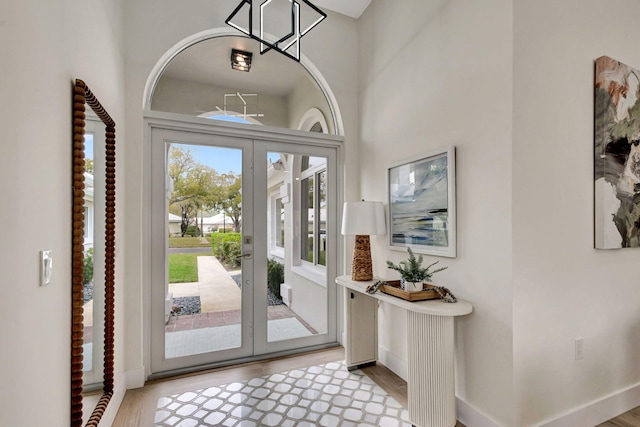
[169,256,242,313]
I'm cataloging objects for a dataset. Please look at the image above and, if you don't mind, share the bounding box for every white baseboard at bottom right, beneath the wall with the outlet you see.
[536,383,640,427]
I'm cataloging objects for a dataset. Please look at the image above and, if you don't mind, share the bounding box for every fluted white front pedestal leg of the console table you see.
[407,311,456,427]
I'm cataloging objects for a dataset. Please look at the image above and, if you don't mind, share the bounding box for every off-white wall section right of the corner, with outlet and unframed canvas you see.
[513,0,640,426]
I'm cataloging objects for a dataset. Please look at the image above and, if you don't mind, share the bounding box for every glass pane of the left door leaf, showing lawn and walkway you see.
[165,143,242,358]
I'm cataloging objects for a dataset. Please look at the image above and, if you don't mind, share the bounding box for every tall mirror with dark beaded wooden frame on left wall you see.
[71,80,115,427]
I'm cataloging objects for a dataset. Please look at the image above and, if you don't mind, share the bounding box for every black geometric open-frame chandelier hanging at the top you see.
[224,0,327,62]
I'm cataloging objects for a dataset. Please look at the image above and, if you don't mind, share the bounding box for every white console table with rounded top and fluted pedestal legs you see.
[336,276,473,427]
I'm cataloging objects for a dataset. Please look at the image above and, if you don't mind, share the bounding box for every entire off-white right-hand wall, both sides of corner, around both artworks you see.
[359,0,640,426]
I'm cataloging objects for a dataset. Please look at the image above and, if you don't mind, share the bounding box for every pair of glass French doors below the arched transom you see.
[149,126,338,374]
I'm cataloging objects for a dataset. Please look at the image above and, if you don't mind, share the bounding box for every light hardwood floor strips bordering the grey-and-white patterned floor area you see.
[113,347,640,427]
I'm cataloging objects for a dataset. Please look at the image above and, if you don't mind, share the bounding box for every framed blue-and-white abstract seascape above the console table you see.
[387,147,456,257]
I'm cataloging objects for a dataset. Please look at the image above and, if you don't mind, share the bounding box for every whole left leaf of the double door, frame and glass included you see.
[151,130,253,372]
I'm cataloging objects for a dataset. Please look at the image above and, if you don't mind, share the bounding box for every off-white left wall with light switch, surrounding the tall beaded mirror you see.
[0,0,124,426]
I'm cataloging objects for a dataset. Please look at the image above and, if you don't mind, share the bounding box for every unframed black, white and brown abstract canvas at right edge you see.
[594,56,640,249]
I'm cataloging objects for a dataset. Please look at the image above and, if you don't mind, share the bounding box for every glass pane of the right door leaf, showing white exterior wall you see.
[255,145,335,351]
